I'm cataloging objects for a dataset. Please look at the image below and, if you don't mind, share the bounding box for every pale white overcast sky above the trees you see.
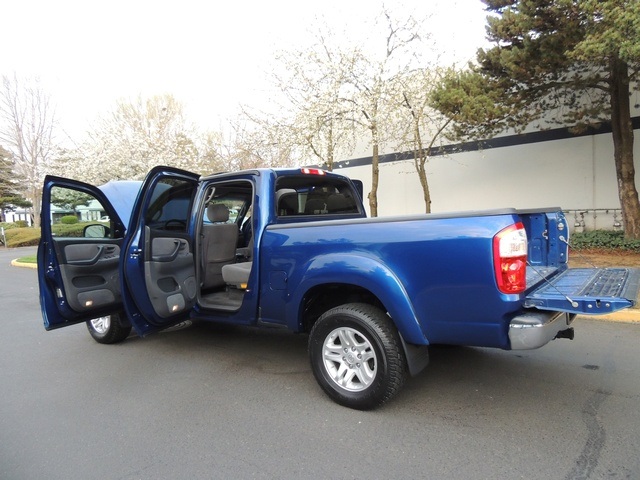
[0,0,486,142]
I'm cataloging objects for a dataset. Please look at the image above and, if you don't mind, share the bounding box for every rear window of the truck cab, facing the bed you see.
[275,175,360,217]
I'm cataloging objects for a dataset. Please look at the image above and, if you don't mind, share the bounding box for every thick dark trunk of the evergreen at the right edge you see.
[610,58,640,240]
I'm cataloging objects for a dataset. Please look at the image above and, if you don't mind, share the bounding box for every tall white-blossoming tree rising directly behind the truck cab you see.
[264,9,430,216]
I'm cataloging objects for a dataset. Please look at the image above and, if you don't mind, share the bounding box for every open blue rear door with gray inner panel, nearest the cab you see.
[121,167,199,335]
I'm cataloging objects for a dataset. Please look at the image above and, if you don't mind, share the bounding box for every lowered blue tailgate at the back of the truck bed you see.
[524,268,640,315]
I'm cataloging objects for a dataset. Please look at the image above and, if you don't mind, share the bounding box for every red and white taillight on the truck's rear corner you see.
[493,222,527,293]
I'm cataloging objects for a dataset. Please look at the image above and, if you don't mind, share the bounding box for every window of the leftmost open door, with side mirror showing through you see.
[49,186,111,238]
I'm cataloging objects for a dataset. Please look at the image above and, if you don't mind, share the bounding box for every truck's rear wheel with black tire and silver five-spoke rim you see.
[309,303,407,410]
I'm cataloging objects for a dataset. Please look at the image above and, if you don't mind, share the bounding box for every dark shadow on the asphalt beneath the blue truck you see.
[131,321,598,415]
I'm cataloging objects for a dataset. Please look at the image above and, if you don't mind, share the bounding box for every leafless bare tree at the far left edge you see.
[0,75,56,227]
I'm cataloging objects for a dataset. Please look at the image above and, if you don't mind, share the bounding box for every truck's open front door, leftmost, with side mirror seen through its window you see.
[38,176,131,330]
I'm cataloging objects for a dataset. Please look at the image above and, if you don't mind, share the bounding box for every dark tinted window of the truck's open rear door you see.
[145,178,195,232]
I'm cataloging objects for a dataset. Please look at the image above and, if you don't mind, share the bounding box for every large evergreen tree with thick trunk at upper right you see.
[434,0,640,239]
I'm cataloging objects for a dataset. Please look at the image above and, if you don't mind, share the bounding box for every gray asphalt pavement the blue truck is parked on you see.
[0,249,640,480]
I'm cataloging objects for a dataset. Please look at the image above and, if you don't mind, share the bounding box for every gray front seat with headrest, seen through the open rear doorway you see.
[202,203,238,288]
